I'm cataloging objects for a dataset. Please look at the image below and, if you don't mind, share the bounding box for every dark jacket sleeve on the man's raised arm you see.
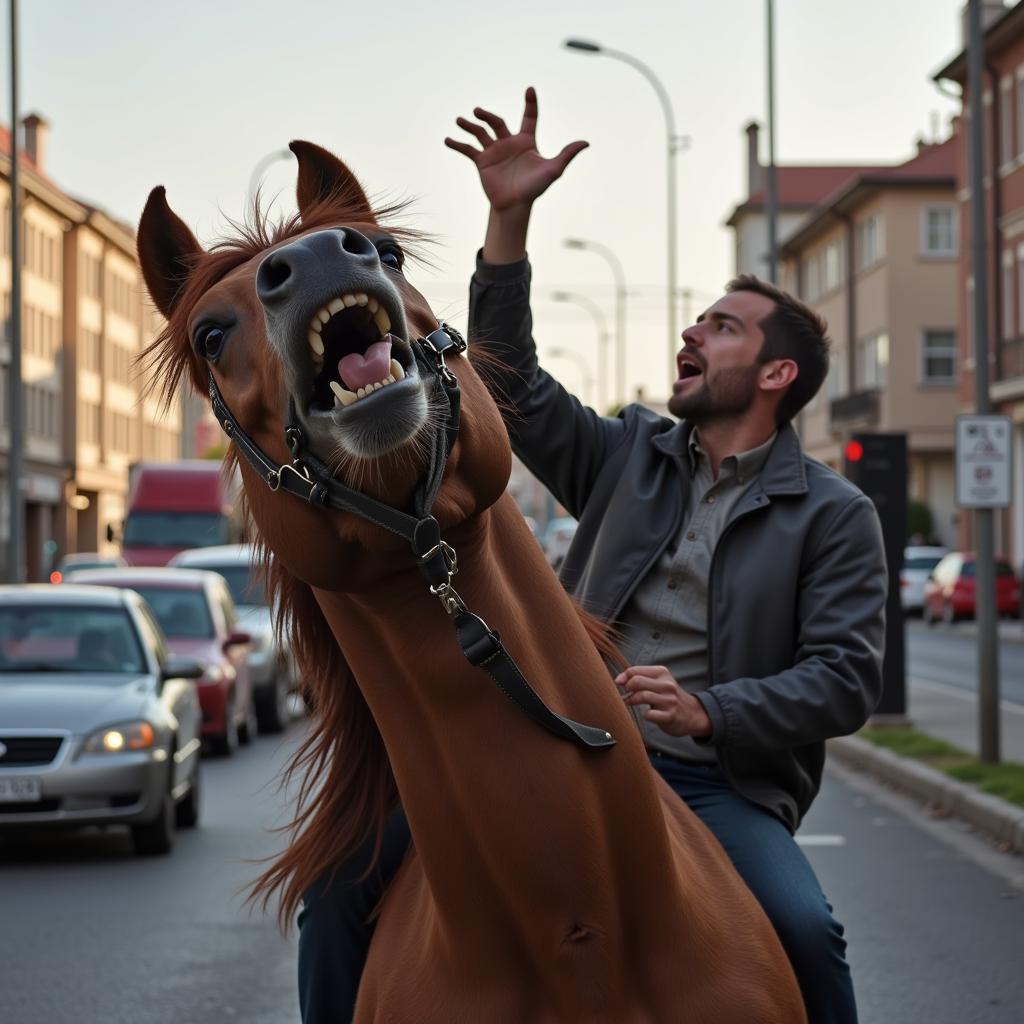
[469,251,626,519]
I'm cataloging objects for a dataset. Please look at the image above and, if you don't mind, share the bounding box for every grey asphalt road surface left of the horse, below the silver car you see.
[0,725,301,1024]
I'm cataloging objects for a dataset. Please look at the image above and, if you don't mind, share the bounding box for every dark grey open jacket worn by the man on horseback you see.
[470,260,888,829]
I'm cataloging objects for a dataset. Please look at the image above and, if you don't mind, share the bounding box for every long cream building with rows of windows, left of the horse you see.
[0,115,209,581]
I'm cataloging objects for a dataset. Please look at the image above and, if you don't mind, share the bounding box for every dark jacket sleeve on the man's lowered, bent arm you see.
[696,495,888,749]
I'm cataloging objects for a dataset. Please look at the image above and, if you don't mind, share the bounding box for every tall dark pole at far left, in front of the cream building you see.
[7,0,25,583]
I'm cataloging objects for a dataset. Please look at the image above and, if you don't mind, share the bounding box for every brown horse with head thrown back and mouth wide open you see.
[138,142,805,1024]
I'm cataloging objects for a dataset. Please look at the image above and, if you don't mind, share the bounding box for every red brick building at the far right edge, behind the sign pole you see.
[934,3,1024,566]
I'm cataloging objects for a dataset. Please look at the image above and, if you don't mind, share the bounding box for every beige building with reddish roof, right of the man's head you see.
[779,139,959,545]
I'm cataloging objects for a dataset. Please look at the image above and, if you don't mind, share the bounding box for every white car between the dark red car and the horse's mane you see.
[168,544,298,732]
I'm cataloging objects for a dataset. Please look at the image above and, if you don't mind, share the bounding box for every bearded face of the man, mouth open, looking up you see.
[669,292,775,425]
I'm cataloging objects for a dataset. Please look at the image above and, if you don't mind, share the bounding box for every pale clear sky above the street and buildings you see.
[0,0,974,400]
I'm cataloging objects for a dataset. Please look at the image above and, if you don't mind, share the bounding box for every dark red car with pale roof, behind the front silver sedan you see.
[69,566,257,754]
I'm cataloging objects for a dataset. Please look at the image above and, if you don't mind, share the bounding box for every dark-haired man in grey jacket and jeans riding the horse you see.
[300,89,887,1024]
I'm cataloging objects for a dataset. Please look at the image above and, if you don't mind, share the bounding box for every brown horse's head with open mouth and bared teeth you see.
[138,141,511,590]
